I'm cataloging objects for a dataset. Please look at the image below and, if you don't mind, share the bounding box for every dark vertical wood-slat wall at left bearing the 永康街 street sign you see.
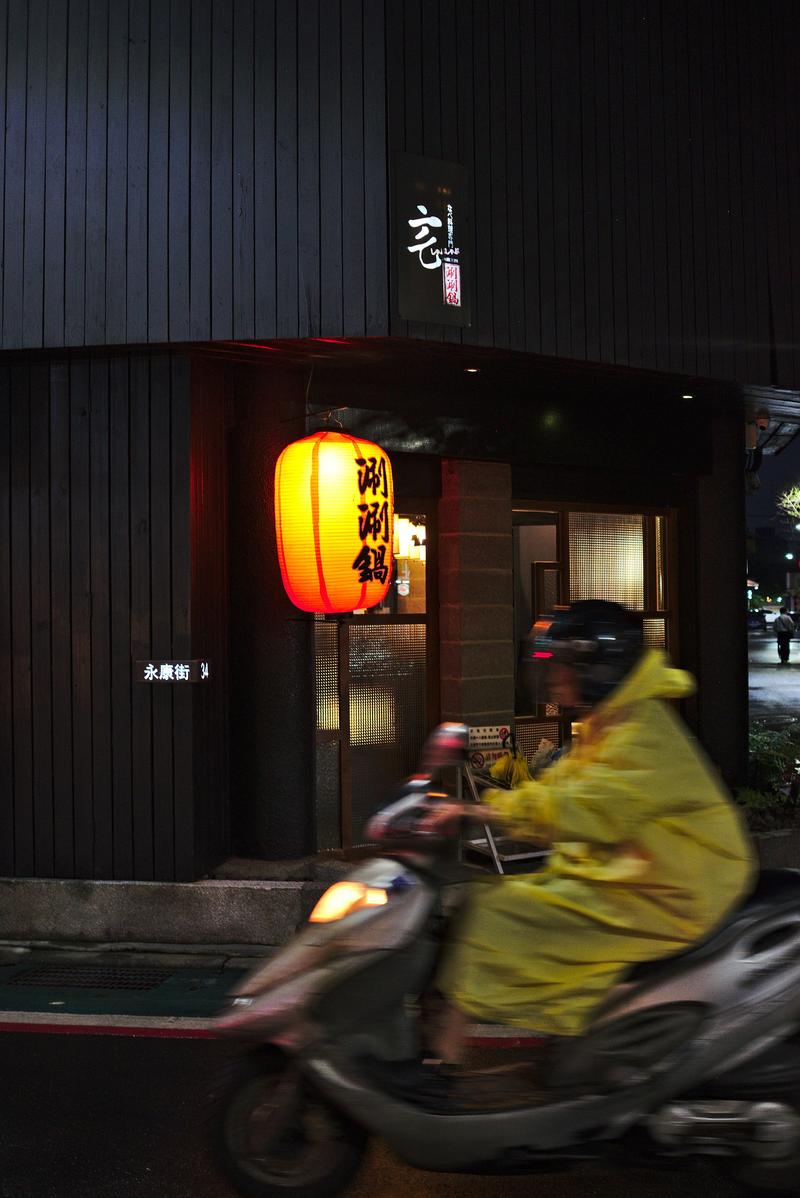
[0,355,209,879]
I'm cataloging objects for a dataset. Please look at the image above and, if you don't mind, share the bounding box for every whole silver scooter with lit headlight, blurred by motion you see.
[217,725,800,1198]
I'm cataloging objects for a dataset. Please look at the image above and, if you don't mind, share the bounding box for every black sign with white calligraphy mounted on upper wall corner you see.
[393,155,472,327]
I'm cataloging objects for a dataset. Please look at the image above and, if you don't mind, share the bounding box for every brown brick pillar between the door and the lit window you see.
[440,459,514,725]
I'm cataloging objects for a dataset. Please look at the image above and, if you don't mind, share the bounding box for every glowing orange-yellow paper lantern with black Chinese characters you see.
[275,429,394,612]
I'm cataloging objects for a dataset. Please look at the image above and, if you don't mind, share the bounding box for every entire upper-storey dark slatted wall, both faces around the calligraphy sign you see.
[0,0,800,386]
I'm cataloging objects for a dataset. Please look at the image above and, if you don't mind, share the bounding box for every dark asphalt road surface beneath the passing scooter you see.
[0,1034,733,1198]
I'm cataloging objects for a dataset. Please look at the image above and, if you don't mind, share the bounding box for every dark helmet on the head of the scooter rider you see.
[537,599,643,707]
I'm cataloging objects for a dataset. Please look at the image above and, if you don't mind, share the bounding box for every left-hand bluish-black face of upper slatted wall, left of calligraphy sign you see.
[0,0,387,347]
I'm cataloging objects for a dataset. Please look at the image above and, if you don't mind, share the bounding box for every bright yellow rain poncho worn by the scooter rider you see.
[438,649,754,1035]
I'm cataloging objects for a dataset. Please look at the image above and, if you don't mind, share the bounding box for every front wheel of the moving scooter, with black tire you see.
[217,1047,366,1198]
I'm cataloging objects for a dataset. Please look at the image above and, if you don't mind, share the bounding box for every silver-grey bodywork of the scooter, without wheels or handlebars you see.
[216,858,800,1173]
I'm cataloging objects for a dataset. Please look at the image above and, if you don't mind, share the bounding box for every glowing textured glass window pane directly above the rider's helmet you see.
[569,512,644,611]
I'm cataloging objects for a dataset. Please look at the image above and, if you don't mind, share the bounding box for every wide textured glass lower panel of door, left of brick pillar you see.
[350,624,428,842]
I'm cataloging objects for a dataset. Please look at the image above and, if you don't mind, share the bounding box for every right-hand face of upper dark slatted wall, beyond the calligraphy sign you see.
[387,0,800,386]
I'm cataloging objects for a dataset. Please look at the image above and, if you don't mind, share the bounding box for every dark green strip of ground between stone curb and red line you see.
[0,958,244,1018]
